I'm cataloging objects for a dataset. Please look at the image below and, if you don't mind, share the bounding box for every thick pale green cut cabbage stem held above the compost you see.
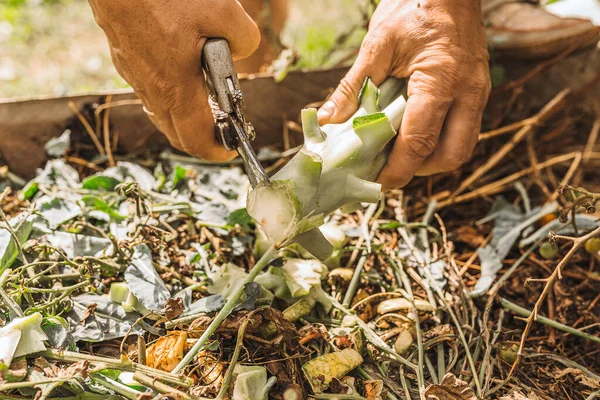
[247,78,406,260]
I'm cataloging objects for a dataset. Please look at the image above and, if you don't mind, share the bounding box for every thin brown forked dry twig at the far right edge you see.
[507,227,600,378]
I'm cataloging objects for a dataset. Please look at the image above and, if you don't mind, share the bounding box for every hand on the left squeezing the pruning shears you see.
[89,0,260,161]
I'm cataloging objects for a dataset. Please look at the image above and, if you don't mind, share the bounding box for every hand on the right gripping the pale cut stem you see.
[319,0,491,189]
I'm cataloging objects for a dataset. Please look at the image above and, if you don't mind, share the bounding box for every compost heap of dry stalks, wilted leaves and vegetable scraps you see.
[0,90,600,400]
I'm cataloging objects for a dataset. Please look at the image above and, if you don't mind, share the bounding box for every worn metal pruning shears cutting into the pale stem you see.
[202,38,269,188]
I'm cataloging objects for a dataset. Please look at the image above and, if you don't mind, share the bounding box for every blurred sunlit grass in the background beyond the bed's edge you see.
[0,0,369,98]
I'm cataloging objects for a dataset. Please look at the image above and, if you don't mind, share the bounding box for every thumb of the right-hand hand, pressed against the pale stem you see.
[317,37,389,125]
